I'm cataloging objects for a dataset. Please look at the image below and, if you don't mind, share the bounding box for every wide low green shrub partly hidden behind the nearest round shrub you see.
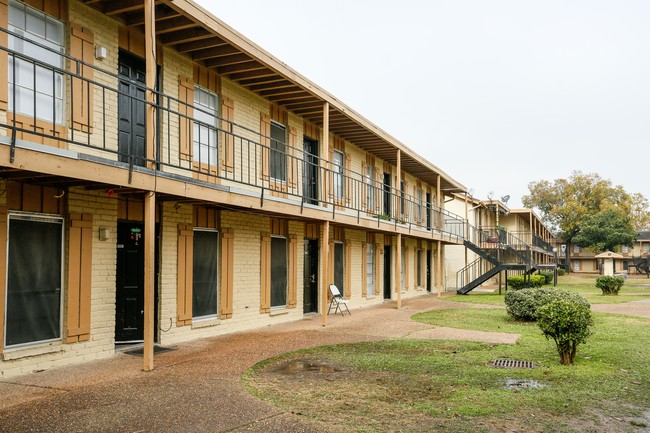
[505,288,590,322]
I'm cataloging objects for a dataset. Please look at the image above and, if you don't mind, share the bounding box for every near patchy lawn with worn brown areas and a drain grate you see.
[243,280,650,433]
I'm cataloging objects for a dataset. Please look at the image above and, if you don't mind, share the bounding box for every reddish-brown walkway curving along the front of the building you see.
[0,295,518,433]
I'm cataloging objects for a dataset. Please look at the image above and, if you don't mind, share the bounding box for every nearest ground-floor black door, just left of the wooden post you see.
[115,222,144,343]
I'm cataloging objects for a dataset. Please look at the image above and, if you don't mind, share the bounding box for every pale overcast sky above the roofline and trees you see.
[198,0,650,208]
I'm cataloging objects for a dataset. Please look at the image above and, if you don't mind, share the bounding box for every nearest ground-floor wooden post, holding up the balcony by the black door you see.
[143,191,156,371]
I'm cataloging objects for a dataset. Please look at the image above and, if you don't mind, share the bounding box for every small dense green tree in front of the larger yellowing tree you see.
[572,208,638,253]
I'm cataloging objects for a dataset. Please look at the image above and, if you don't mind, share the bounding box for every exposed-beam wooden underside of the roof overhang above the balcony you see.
[82,0,465,193]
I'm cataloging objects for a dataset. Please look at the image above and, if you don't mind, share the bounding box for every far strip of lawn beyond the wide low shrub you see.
[445,274,650,305]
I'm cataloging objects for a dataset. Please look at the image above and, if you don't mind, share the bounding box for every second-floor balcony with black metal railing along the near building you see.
[0,29,466,242]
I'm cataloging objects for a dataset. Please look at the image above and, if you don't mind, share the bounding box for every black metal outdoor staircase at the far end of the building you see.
[456,227,555,295]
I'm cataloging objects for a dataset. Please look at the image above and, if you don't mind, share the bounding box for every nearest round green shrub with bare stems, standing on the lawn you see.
[537,299,593,365]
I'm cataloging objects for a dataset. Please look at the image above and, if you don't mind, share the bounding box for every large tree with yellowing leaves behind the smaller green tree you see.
[522,171,650,269]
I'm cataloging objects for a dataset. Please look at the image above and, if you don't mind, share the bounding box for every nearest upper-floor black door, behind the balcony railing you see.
[117,51,147,166]
